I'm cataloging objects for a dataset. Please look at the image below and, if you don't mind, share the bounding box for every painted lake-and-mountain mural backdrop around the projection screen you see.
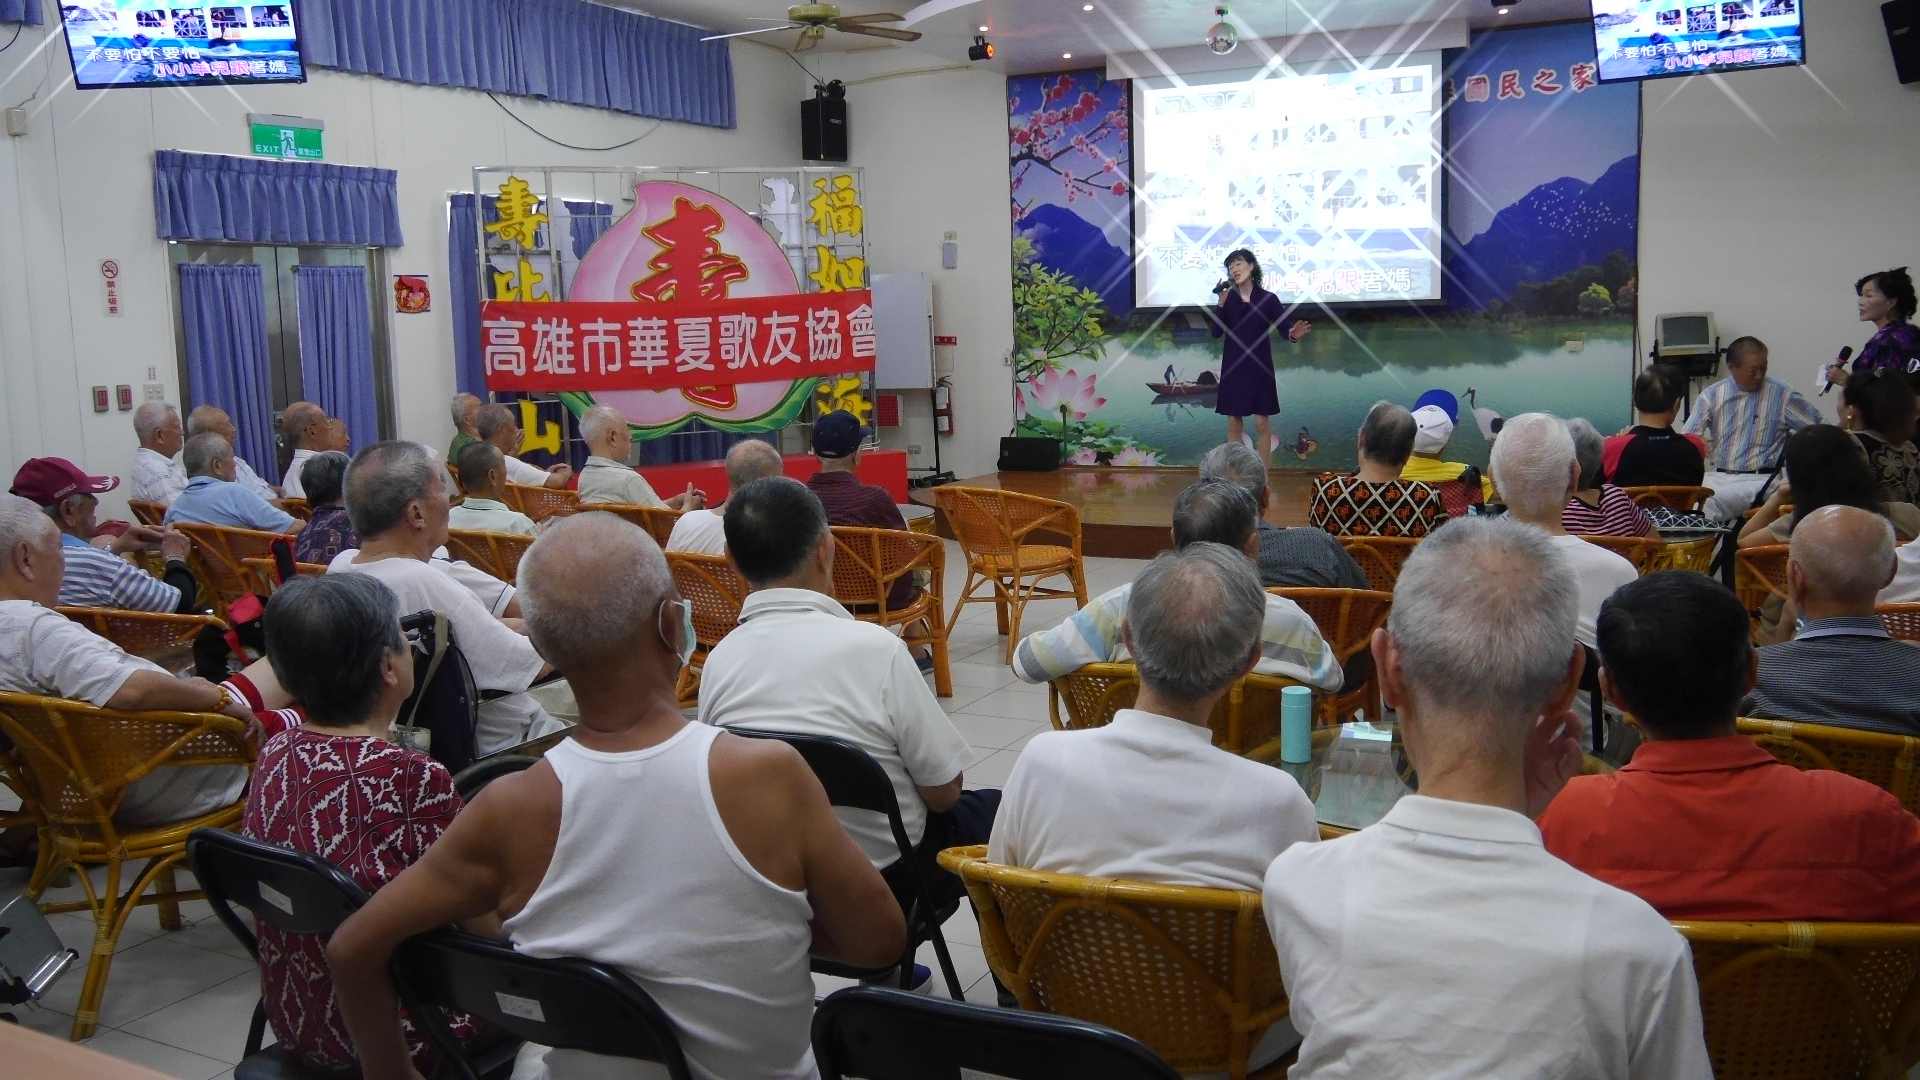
[1008,25,1640,469]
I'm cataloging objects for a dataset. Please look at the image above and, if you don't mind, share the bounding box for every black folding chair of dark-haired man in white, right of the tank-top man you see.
[728,728,966,1001]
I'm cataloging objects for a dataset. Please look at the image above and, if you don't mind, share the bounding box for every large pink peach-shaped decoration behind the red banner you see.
[568,181,810,434]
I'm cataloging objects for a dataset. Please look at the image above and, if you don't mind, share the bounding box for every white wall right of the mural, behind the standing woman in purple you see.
[1640,0,1920,411]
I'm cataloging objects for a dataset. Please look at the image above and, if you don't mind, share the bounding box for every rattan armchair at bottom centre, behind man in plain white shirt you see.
[939,847,1288,1080]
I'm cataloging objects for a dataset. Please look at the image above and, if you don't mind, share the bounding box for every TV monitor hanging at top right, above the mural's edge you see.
[1592,0,1807,83]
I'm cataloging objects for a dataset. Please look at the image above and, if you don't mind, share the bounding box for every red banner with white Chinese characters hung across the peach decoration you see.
[480,288,876,392]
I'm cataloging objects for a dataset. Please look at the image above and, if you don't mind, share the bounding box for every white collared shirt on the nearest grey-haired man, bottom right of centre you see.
[1267,796,1713,1080]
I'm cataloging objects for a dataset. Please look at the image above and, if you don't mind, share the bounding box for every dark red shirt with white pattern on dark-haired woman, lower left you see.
[240,726,474,1072]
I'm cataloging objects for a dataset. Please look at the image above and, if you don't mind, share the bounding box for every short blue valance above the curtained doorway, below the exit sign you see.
[154,150,405,248]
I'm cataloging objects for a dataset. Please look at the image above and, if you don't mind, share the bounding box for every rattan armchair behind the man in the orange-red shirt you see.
[1674,922,1920,1080]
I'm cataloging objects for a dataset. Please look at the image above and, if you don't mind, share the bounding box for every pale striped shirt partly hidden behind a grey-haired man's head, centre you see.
[1014,582,1344,690]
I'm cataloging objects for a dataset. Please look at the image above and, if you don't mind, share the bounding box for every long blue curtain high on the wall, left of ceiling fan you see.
[300,0,733,127]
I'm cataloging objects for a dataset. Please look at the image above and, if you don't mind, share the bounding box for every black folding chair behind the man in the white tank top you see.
[392,930,689,1080]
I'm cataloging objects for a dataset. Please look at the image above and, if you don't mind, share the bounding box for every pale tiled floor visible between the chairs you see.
[0,544,1142,1080]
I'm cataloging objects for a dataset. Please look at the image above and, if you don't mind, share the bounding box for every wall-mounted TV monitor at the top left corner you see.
[60,0,307,90]
